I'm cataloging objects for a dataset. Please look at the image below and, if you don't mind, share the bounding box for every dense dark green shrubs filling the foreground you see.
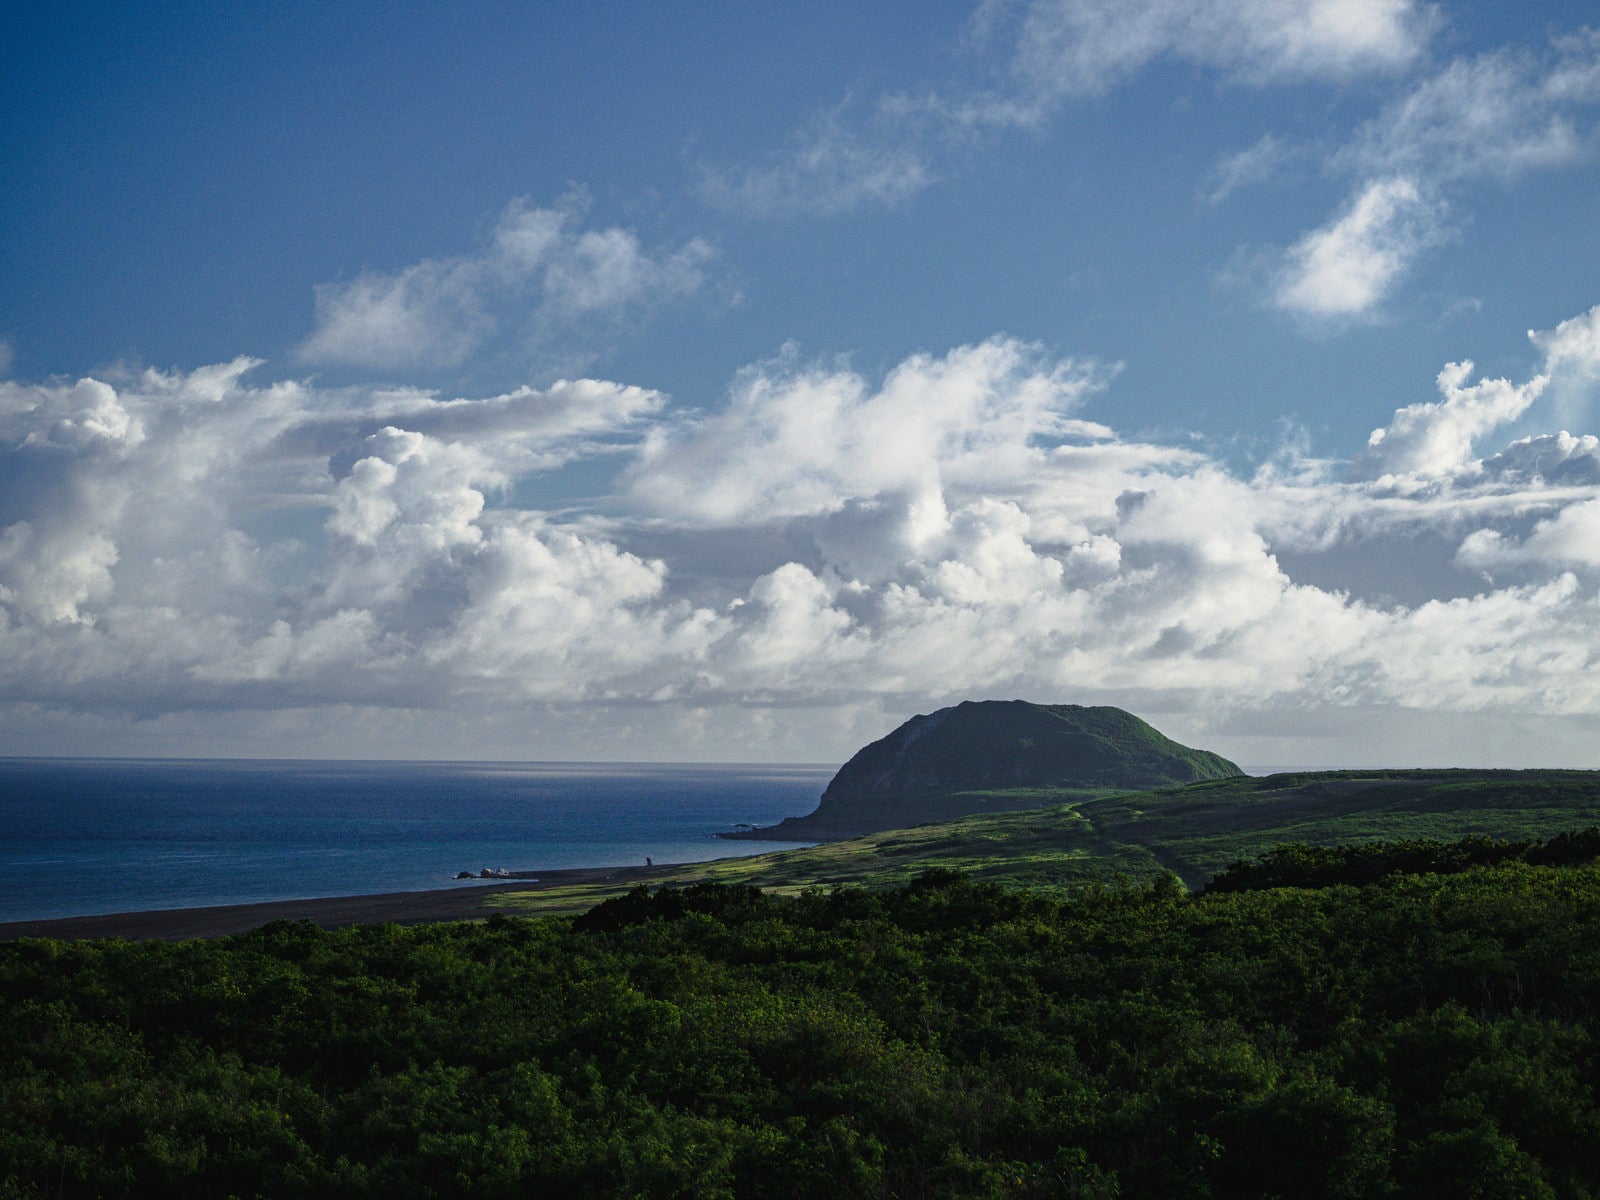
[9,840,1600,1200]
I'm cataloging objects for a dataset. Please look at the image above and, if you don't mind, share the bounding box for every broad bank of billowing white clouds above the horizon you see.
[9,307,1600,758]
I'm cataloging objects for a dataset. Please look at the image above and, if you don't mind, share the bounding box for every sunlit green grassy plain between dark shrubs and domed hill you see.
[483,770,1600,914]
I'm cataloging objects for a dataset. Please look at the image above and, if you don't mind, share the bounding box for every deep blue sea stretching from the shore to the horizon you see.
[0,758,834,922]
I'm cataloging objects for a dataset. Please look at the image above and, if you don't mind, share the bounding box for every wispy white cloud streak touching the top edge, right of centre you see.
[699,0,1434,216]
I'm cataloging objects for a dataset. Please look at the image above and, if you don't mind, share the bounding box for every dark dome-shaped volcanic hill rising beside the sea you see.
[732,701,1243,840]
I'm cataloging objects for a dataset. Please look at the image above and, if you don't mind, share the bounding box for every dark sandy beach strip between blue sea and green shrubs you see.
[0,862,691,941]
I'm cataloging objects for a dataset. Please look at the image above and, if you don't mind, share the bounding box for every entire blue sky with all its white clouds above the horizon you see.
[0,0,1600,766]
